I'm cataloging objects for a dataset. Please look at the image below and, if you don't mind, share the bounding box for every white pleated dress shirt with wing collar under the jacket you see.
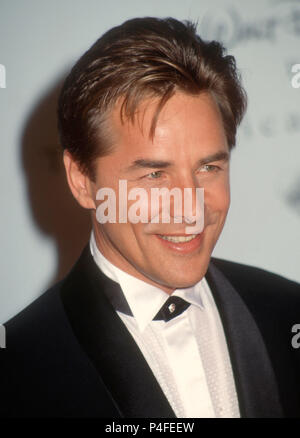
[90,229,240,418]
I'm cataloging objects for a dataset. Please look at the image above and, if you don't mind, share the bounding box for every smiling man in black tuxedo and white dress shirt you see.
[1,18,300,418]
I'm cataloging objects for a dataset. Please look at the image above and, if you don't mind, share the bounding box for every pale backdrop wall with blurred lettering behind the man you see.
[0,0,300,323]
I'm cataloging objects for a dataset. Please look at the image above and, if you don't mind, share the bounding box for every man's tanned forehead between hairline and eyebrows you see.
[110,92,227,155]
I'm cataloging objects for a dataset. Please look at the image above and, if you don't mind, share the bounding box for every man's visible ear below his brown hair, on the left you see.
[63,151,96,210]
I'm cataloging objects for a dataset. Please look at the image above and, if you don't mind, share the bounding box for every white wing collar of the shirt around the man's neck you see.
[90,232,204,332]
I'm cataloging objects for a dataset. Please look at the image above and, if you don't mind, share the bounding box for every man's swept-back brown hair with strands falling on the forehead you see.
[58,17,247,177]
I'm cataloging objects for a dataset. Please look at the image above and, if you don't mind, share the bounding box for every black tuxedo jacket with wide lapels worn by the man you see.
[0,247,300,418]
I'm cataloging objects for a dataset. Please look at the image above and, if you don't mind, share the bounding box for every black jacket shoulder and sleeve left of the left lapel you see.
[0,277,117,418]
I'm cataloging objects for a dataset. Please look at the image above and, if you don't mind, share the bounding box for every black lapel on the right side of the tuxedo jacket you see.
[206,261,283,418]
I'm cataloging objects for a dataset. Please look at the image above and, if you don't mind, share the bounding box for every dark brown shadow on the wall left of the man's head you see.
[21,76,90,284]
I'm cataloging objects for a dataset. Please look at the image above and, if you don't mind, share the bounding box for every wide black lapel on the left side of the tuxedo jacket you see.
[61,247,175,418]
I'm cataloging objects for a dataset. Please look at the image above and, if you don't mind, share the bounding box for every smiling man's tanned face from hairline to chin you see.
[92,93,230,293]
